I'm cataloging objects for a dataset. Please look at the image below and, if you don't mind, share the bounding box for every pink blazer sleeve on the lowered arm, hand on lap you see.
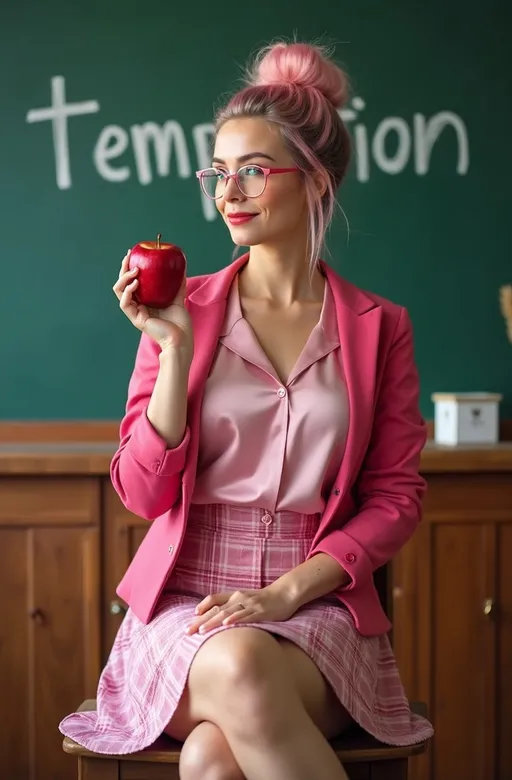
[311,309,427,590]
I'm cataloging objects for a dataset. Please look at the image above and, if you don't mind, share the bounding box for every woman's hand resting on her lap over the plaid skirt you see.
[186,583,297,636]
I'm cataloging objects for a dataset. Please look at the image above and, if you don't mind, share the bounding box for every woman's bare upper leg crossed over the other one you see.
[166,628,347,780]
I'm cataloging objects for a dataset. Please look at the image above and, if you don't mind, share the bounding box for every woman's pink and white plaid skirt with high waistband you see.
[59,505,433,754]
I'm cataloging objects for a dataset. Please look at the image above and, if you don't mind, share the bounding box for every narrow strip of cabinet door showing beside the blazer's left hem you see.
[102,479,150,663]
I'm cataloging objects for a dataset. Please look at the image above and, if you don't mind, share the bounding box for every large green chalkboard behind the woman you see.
[0,0,512,419]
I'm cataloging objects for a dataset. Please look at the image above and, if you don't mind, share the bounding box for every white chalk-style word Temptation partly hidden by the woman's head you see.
[26,76,469,221]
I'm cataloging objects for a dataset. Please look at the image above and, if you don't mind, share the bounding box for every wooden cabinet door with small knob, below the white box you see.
[428,522,495,780]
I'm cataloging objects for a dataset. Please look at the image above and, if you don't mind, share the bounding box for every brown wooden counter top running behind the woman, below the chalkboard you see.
[0,441,512,476]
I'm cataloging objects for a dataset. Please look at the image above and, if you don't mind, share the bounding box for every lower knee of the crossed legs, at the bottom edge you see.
[179,721,244,780]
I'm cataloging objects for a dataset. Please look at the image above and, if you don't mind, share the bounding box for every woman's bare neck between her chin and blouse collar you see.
[239,245,325,307]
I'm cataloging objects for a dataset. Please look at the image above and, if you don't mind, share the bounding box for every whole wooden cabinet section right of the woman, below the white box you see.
[393,464,512,780]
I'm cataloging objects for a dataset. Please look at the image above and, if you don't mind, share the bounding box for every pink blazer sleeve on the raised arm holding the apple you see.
[110,334,190,520]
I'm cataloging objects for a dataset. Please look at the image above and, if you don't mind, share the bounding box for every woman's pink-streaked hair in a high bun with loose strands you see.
[215,42,350,269]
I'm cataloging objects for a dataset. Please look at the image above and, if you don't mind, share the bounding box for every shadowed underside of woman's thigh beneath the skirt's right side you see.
[277,637,352,739]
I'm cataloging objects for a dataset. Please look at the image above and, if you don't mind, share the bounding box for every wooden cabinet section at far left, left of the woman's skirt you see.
[0,478,100,780]
